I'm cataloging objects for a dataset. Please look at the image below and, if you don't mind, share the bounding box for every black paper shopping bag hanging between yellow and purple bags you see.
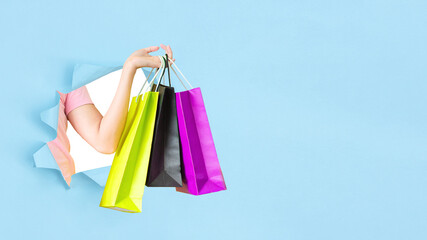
[146,55,182,187]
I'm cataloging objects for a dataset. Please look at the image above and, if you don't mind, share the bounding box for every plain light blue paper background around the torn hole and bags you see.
[0,0,427,240]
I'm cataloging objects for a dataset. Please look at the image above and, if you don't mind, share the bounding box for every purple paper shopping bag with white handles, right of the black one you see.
[171,59,226,195]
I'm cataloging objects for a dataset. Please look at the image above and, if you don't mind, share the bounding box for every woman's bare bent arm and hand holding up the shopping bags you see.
[68,44,174,154]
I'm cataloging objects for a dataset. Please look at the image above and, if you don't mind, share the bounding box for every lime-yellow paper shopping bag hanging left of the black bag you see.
[100,58,167,212]
